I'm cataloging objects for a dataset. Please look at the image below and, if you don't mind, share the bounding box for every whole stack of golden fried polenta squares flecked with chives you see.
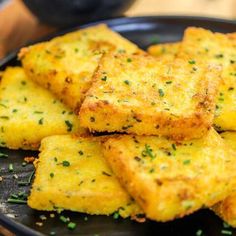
[0,25,236,226]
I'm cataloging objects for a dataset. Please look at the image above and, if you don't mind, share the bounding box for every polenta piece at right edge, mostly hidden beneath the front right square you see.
[213,132,236,227]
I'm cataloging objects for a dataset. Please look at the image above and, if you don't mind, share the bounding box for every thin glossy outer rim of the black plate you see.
[0,15,236,236]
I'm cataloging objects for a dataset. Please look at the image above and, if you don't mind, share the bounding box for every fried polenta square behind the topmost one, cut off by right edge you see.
[178,27,236,131]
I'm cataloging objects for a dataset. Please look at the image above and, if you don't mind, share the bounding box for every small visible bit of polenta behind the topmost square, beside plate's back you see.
[147,42,180,60]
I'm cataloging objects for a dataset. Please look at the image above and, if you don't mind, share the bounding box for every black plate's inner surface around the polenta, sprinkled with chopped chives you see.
[0,16,236,236]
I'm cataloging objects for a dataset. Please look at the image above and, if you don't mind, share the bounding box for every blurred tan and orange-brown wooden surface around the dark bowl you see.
[0,0,236,236]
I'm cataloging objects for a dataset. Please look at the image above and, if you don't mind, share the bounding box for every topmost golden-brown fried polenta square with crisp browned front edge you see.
[79,54,220,139]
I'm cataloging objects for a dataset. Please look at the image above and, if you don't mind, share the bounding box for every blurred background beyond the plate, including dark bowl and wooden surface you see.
[0,0,236,58]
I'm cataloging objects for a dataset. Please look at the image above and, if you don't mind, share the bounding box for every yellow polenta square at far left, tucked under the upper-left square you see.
[0,67,86,150]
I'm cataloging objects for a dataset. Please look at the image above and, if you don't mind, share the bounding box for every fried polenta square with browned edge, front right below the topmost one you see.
[103,129,236,222]
